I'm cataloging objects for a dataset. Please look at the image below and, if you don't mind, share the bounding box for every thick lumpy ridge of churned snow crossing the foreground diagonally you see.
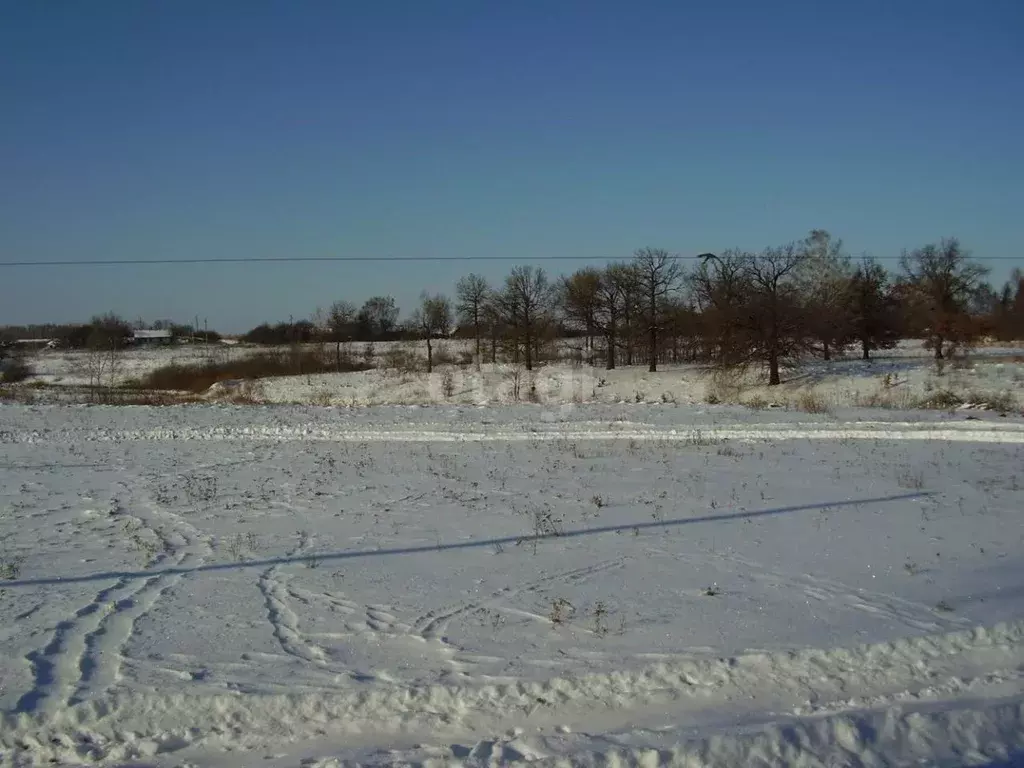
[8,622,1024,765]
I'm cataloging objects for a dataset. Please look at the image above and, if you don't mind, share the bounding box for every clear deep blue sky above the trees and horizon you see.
[0,0,1024,331]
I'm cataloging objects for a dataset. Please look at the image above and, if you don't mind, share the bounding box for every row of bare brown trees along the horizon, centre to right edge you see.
[290,229,1024,384]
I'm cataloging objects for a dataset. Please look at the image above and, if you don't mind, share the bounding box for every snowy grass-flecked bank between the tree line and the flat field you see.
[18,340,1024,411]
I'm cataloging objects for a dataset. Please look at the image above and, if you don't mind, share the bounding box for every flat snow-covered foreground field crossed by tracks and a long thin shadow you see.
[0,403,1024,768]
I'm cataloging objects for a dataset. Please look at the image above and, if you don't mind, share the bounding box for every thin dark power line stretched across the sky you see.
[0,254,1024,267]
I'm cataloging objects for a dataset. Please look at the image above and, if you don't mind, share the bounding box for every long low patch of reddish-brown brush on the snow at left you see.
[139,349,372,392]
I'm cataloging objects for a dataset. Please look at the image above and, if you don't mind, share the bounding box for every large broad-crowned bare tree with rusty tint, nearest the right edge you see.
[900,238,988,360]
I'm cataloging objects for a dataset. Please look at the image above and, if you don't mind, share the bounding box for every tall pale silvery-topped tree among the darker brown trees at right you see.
[801,229,853,360]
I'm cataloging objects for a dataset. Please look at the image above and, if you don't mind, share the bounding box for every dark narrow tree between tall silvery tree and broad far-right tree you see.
[848,257,902,360]
